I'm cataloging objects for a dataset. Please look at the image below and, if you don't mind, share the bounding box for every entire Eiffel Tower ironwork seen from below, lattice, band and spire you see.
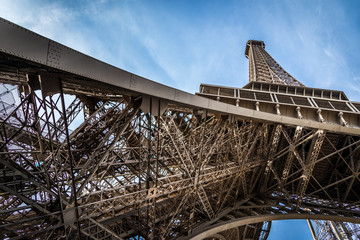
[0,18,360,240]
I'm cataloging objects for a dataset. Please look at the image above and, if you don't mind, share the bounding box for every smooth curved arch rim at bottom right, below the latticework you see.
[189,213,360,240]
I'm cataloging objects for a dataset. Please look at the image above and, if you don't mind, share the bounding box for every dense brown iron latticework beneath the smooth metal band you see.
[0,68,360,240]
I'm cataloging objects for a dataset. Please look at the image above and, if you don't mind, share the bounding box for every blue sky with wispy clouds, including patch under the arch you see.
[0,0,360,239]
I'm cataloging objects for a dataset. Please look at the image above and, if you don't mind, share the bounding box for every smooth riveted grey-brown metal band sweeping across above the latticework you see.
[0,18,360,134]
